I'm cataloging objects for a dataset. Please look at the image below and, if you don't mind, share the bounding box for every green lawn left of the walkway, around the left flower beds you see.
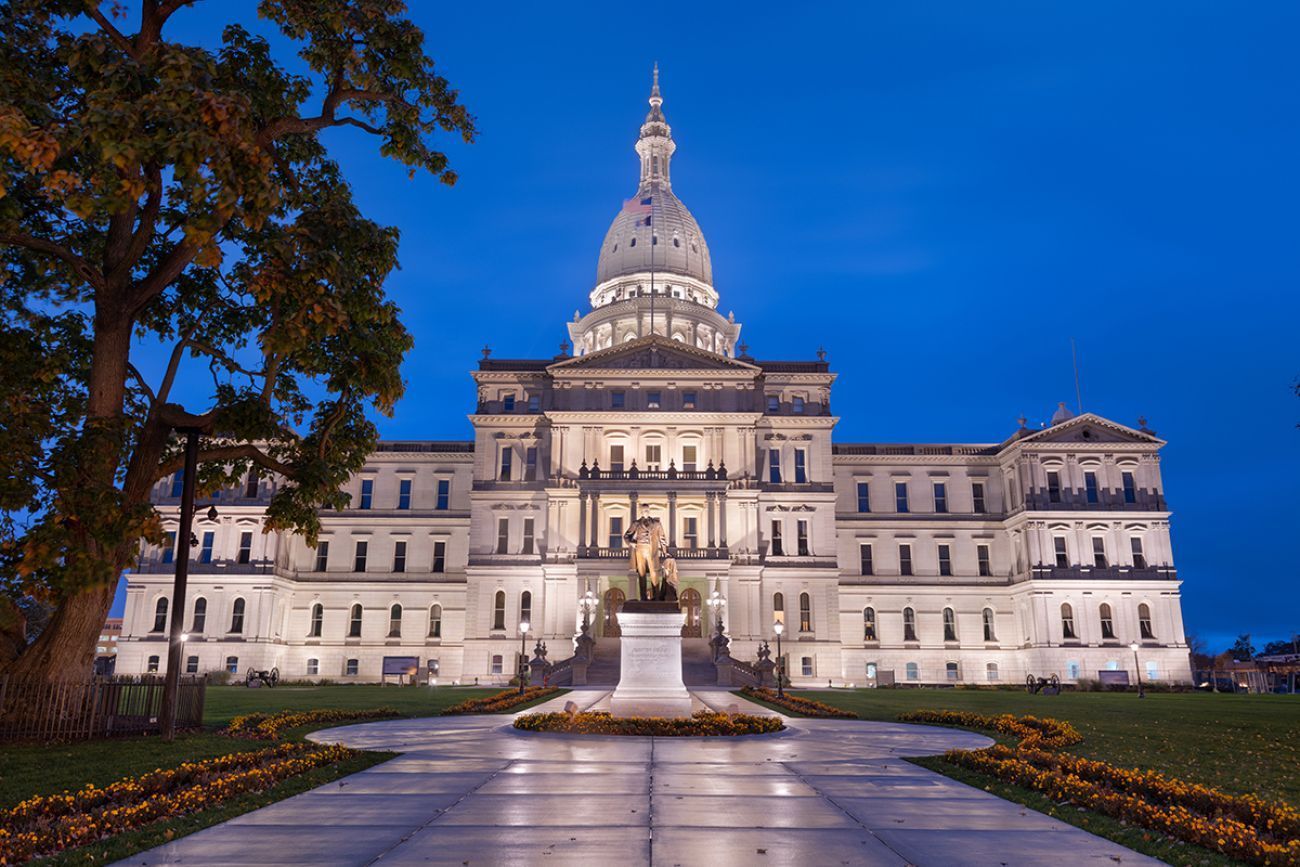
[0,685,554,864]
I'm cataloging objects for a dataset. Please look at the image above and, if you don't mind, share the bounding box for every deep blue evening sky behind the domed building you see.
[116,0,1300,645]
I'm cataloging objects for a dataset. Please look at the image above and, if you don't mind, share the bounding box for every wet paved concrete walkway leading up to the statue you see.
[120,689,1158,867]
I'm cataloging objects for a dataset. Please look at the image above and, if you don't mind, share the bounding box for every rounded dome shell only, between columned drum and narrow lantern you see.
[595,183,714,286]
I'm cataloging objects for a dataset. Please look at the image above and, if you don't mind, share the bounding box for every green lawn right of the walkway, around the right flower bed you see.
[777,689,1300,867]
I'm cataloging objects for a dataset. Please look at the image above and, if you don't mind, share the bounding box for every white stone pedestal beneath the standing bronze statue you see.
[610,601,690,716]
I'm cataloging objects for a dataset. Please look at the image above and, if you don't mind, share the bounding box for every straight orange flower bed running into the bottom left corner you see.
[0,744,358,864]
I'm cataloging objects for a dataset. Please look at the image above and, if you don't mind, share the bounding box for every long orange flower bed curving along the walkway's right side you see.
[915,711,1300,864]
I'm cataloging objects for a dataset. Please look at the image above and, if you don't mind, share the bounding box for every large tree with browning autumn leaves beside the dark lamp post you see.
[0,0,475,680]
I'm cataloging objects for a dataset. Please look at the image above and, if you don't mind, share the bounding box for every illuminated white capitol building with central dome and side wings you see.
[117,71,1190,686]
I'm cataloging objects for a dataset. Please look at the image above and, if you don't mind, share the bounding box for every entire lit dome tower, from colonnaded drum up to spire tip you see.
[569,65,740,356]
